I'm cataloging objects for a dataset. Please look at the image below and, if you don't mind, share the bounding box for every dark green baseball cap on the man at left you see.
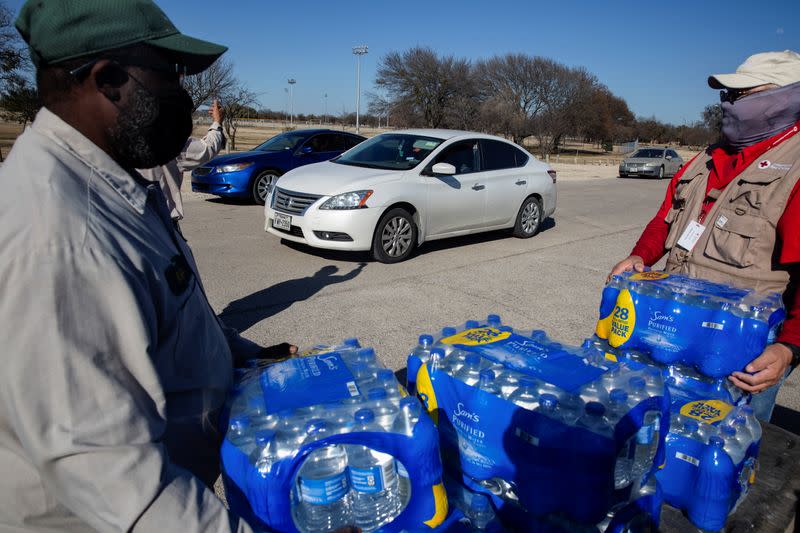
[15,0,228,74]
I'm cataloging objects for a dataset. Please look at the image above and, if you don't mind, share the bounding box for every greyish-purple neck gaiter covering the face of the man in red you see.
[722,82,800,151]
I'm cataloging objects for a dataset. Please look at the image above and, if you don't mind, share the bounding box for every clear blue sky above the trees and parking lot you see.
[9,0,800,124]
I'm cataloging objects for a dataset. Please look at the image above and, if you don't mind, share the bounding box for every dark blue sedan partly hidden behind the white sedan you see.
[192,129,364,205]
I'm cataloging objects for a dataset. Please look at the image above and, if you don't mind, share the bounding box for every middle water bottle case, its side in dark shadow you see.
[408,315,669,530]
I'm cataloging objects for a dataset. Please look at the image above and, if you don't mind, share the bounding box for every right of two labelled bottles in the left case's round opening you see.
[347,409,400,532]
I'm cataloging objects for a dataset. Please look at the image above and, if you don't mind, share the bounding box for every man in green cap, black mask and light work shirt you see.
[0,0,300,531]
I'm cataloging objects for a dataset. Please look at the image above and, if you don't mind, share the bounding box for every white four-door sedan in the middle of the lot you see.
[264,129,556,263]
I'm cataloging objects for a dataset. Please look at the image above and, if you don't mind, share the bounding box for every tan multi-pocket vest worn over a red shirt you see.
[664,126,800,293]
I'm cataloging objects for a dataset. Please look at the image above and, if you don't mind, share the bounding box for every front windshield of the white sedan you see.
[333,133,444,170]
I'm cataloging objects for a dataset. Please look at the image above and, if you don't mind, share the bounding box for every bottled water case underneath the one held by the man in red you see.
[584,337,761,530]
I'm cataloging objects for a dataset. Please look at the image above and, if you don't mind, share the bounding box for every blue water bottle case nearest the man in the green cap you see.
[221,339,447,533]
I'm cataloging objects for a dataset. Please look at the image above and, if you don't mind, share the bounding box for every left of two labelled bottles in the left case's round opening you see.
[297,419,353,533]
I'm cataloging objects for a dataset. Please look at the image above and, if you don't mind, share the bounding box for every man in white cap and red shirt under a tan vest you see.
[610,50,800,420]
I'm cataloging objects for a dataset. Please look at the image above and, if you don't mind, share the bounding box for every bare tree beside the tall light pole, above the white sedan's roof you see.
[375,47,470,128]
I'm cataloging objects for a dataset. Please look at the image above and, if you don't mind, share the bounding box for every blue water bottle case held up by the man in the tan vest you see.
[595,272,786,378]
